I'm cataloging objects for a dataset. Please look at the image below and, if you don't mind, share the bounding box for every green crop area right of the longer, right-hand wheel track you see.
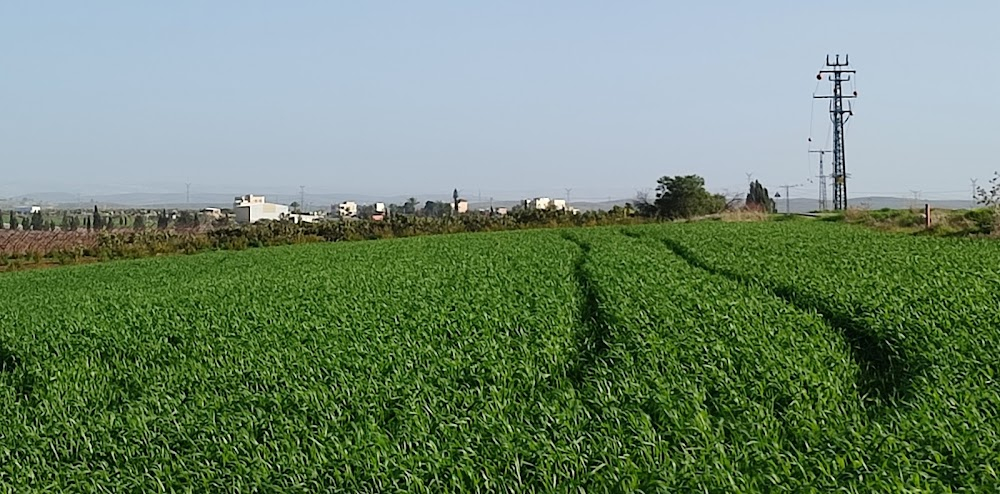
[630,222,1000,491]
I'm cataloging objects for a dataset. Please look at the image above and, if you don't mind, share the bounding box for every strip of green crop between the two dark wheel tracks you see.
[567,230,866,492]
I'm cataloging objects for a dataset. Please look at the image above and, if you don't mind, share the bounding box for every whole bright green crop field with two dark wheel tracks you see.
[0,221,1000,492]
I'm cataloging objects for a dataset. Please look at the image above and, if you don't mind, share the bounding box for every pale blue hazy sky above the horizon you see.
[0,0,1000,199]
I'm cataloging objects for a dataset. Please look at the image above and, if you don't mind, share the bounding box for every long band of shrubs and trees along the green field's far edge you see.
[0,175,773,264]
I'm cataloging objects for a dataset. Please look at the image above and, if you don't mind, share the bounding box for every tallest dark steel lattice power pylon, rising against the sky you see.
[813,55,858,211]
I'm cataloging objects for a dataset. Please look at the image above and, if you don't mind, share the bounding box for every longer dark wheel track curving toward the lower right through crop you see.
[622,230,913,407]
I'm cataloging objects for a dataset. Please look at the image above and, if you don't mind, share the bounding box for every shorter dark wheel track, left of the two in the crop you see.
[563,233,611,388]
